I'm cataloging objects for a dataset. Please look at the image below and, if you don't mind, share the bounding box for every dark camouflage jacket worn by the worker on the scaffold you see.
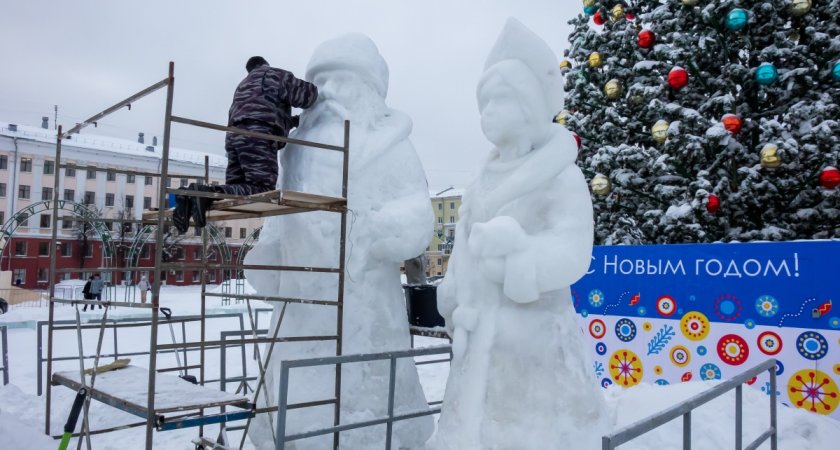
[228,64,318,136]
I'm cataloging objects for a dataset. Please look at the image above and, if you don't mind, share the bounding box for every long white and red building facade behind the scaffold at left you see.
[0,118,261,289]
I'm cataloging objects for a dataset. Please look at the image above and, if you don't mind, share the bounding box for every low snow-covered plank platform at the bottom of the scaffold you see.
[52,366,249,419]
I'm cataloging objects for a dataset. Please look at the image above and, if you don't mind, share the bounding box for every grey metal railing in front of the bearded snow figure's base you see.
[275,345,452,450]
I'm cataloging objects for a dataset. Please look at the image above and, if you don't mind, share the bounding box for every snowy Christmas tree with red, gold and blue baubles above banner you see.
[555,0,840,244]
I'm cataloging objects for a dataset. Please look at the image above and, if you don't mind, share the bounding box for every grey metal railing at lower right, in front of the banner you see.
[601,359,778,450]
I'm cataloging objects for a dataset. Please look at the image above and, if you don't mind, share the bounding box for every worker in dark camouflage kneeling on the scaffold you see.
[173,56,318,234]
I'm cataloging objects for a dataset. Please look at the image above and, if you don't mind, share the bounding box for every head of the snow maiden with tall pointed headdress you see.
[477,19,563,158]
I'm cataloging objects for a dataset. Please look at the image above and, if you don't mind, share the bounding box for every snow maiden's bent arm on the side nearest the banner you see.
[504,165,594,303]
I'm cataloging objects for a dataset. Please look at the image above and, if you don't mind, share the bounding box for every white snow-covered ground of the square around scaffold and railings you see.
[0,287,840,450]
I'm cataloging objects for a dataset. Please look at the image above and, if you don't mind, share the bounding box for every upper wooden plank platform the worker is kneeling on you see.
[143,190,347,222]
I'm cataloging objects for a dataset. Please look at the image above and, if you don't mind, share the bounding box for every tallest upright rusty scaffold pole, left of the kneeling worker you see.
[146,61,177,450]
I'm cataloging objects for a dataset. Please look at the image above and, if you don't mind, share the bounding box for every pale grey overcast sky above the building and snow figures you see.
[0,0,581,189]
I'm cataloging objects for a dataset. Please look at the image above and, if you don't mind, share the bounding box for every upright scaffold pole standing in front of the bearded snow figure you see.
[333,120,350,450]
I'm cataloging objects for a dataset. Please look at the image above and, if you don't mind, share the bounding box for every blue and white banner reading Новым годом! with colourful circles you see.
[572,241,840,420]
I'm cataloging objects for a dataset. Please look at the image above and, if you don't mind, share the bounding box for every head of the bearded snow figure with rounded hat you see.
[306,33,388,120]
